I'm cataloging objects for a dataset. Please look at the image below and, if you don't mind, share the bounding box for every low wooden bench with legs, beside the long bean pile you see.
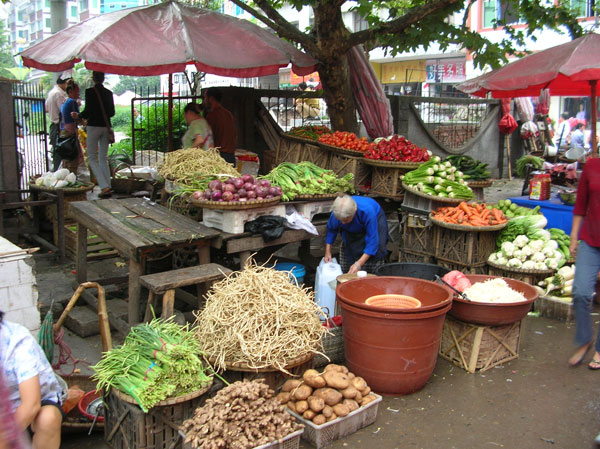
[140,263,231,322]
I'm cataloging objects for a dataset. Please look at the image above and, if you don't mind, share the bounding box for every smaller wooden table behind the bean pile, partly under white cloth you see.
[211,220,327,268]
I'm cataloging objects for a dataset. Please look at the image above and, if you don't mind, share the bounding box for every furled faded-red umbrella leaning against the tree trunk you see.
[348,46,394,139]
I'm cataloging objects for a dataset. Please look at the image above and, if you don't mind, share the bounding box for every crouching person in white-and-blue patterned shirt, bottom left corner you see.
[0,312,63,449]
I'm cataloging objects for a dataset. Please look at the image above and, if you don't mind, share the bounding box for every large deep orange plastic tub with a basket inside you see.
[336,276,453,395]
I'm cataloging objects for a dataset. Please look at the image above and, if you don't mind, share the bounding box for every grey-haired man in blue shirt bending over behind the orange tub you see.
[325,195,389,274]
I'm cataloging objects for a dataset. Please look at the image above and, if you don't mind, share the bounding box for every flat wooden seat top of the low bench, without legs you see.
[140,263,231,293]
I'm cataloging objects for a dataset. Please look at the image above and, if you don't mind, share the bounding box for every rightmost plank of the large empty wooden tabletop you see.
[121,198,219,239]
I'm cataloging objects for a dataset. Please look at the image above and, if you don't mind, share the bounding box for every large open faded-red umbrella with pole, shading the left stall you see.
[20,1,316,150]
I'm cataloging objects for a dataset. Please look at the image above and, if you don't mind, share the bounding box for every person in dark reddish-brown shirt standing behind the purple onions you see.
[204,87,237,164]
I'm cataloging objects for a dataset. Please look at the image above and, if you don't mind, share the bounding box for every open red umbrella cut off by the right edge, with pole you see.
[457,33,600,155]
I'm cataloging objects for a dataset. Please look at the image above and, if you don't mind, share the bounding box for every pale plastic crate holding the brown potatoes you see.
[288,394,381,449]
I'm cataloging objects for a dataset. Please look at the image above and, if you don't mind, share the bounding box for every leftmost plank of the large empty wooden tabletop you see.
[71,200,151,258]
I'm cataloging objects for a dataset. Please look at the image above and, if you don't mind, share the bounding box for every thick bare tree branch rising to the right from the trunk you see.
[347,0,462,48]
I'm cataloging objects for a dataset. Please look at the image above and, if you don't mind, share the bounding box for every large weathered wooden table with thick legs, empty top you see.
[70,198,220,325]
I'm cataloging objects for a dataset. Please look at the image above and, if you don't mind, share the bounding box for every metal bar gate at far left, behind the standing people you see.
[13,84,51,188]
